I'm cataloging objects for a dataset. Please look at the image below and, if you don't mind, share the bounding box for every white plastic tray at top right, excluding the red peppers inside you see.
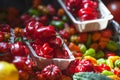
[58,0,113,32]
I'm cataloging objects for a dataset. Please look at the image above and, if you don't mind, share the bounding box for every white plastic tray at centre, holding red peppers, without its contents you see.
[25,37,75,70]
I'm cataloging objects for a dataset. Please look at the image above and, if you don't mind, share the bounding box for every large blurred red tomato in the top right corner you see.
[107,1,120,23]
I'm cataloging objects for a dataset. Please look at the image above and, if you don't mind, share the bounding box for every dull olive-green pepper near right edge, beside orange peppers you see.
[106,40,119,51]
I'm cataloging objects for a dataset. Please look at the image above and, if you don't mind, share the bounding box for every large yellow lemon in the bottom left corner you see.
[0,61,19,80]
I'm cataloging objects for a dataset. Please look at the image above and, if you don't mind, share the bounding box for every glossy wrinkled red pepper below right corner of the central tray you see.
[66,59,94,75]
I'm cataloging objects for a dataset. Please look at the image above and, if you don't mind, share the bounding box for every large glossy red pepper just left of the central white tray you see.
[11,42,29,57]
